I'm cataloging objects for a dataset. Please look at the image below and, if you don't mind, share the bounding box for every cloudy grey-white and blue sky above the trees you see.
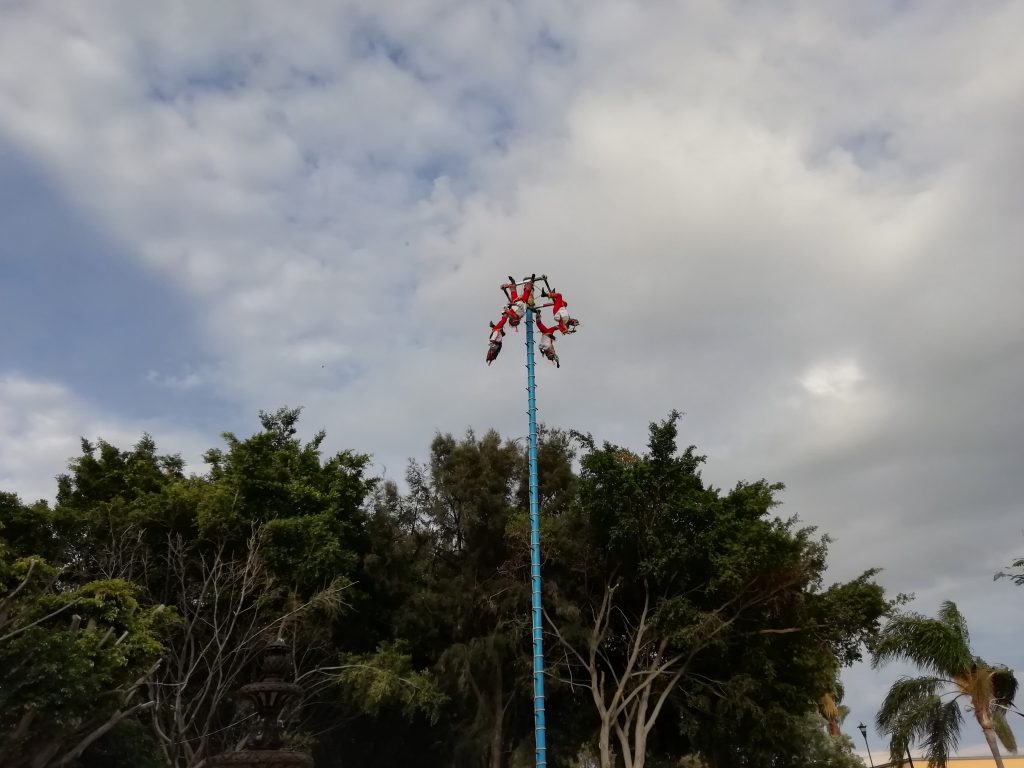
[0,0,1024,755]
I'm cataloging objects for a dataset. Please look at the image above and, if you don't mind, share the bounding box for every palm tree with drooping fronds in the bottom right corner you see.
[872,600,1017,768]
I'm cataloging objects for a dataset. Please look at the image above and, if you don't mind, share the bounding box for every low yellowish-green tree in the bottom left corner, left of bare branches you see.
[0,507,172,768]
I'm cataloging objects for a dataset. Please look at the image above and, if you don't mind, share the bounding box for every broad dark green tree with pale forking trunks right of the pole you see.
[546,414,888,768]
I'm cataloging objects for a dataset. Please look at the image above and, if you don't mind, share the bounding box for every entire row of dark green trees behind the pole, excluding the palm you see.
[0,408,897,768]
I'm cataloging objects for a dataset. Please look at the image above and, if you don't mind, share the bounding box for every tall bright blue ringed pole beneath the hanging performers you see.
[526,311,548,768]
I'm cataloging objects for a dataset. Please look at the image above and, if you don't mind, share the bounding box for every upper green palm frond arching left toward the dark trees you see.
[871,603,974,677]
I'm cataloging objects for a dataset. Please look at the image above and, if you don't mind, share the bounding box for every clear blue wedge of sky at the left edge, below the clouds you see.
[0,139,232,422]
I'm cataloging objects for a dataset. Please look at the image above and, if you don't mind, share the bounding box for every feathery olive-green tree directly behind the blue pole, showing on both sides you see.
[371,429,575,768]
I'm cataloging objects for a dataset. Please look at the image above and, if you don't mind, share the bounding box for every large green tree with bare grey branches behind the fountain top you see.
[44,409,417,768]
